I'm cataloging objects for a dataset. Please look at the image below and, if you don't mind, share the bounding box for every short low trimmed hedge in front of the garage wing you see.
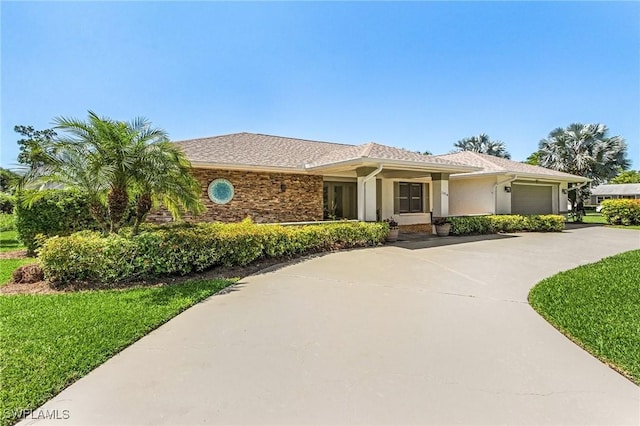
[448,215,564,235]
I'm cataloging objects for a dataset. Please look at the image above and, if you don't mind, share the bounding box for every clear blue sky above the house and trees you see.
[0,1,640,168]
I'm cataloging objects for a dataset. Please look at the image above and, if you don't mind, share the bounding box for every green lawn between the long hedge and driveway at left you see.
[0,280,233,426]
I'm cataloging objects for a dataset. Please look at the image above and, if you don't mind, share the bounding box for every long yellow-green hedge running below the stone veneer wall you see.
[39,220,389,284]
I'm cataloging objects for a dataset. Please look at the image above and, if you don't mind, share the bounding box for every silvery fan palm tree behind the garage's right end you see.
[539,123,629,208]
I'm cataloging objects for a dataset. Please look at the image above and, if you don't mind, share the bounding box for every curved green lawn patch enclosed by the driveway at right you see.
[529,250,640,384]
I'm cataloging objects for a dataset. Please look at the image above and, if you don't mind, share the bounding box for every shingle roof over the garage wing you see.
[437,151,587,182]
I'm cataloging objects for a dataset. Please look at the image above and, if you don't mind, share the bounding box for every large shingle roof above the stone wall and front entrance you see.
[176,133,476,171]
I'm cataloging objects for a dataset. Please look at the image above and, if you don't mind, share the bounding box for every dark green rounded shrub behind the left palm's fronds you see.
[15,189,98,252]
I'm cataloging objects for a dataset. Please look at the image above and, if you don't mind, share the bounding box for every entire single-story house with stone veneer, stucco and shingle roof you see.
[150,133,587,225]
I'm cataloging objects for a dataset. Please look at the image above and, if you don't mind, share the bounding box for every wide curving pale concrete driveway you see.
[24,227,640,425]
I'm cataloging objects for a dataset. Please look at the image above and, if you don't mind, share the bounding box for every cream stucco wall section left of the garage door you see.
[449,177,496,216]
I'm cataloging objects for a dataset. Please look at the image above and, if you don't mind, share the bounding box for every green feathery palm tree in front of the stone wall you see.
[26,111,204,232]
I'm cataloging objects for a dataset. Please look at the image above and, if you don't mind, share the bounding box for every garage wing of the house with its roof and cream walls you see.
[437,151,589,216]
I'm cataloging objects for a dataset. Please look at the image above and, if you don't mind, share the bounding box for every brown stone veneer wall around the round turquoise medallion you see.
[147,169,323,223]
